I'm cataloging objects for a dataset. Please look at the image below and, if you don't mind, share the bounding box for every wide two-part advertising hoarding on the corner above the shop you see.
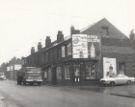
[72,34,101,58]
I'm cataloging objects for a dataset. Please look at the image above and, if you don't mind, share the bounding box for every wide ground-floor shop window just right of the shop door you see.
[85,65,96,80]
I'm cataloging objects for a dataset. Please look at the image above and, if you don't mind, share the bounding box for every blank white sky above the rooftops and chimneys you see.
[0,0,135,64]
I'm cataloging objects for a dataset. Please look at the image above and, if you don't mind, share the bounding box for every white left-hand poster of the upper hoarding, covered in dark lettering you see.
[72,34,88,58]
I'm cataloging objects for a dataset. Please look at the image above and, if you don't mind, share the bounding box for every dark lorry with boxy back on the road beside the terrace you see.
[17,67,43,85]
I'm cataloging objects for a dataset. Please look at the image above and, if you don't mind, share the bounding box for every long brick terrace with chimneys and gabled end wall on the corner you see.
[25,18,135,85]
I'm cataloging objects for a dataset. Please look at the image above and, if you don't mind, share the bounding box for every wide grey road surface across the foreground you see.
[0,80,135,107]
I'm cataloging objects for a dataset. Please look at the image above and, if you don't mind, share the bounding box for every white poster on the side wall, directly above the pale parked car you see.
[103,57,117,78]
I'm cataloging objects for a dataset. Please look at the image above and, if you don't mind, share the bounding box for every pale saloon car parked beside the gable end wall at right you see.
[100,74,135,86]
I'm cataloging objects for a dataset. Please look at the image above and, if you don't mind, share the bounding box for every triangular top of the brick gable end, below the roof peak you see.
[81,18,127,39]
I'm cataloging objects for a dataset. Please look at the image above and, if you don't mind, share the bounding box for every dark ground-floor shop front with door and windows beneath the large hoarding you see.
[44,59,97,85]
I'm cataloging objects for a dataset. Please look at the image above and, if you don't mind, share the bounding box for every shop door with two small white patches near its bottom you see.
[74,65,80,84]
